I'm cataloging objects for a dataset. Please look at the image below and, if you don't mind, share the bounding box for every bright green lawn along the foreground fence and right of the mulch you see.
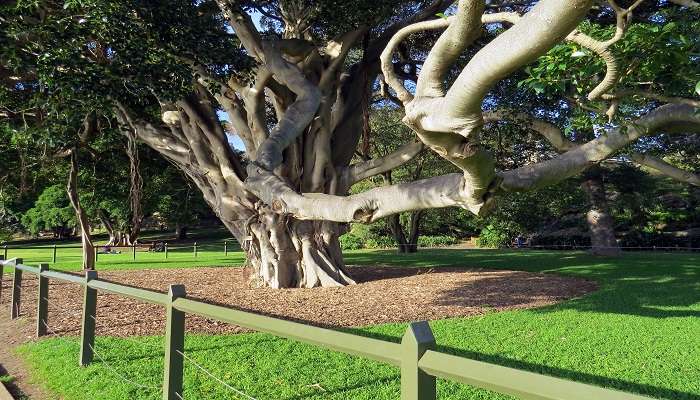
[10,250,700,400]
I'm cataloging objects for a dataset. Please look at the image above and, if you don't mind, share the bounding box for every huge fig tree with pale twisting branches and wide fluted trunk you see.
[2,0,700,288]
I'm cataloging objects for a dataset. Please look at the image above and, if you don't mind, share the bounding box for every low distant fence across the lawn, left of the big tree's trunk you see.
[0,240,240,264]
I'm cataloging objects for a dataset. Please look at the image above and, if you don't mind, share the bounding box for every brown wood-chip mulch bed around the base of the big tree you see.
[0,267,596,336]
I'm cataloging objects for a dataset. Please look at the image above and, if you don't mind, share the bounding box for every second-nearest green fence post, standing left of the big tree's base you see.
[163,285,186,400]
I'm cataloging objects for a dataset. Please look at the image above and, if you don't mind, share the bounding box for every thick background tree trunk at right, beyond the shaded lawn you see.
[582,167,620,255]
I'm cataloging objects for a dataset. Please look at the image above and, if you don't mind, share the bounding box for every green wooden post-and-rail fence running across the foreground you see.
[0,259,649,400]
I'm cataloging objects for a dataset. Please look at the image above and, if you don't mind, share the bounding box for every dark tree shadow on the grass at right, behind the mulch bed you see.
[347,250,700,318]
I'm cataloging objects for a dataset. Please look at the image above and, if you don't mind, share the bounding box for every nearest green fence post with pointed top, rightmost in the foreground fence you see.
[401,321,436,400]
